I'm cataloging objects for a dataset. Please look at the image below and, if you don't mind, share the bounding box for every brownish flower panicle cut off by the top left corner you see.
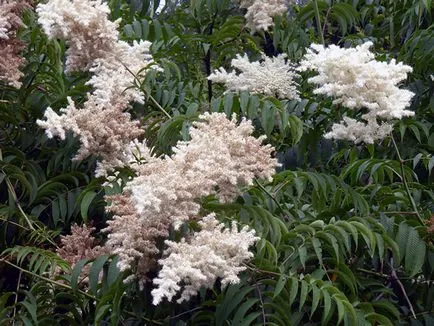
[0,0,32,88]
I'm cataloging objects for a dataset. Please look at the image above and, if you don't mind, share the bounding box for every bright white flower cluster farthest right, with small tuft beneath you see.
[299,42,414,143]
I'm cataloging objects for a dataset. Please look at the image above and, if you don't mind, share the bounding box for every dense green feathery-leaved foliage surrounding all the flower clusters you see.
[0,0,434,325]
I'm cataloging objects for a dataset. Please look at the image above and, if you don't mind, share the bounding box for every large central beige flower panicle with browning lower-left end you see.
[105,113,278,284]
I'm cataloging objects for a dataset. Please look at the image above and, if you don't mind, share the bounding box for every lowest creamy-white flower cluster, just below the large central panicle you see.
[152,214,259,305]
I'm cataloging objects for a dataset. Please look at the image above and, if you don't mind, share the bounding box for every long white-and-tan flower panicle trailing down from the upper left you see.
[36,0,156,175]
